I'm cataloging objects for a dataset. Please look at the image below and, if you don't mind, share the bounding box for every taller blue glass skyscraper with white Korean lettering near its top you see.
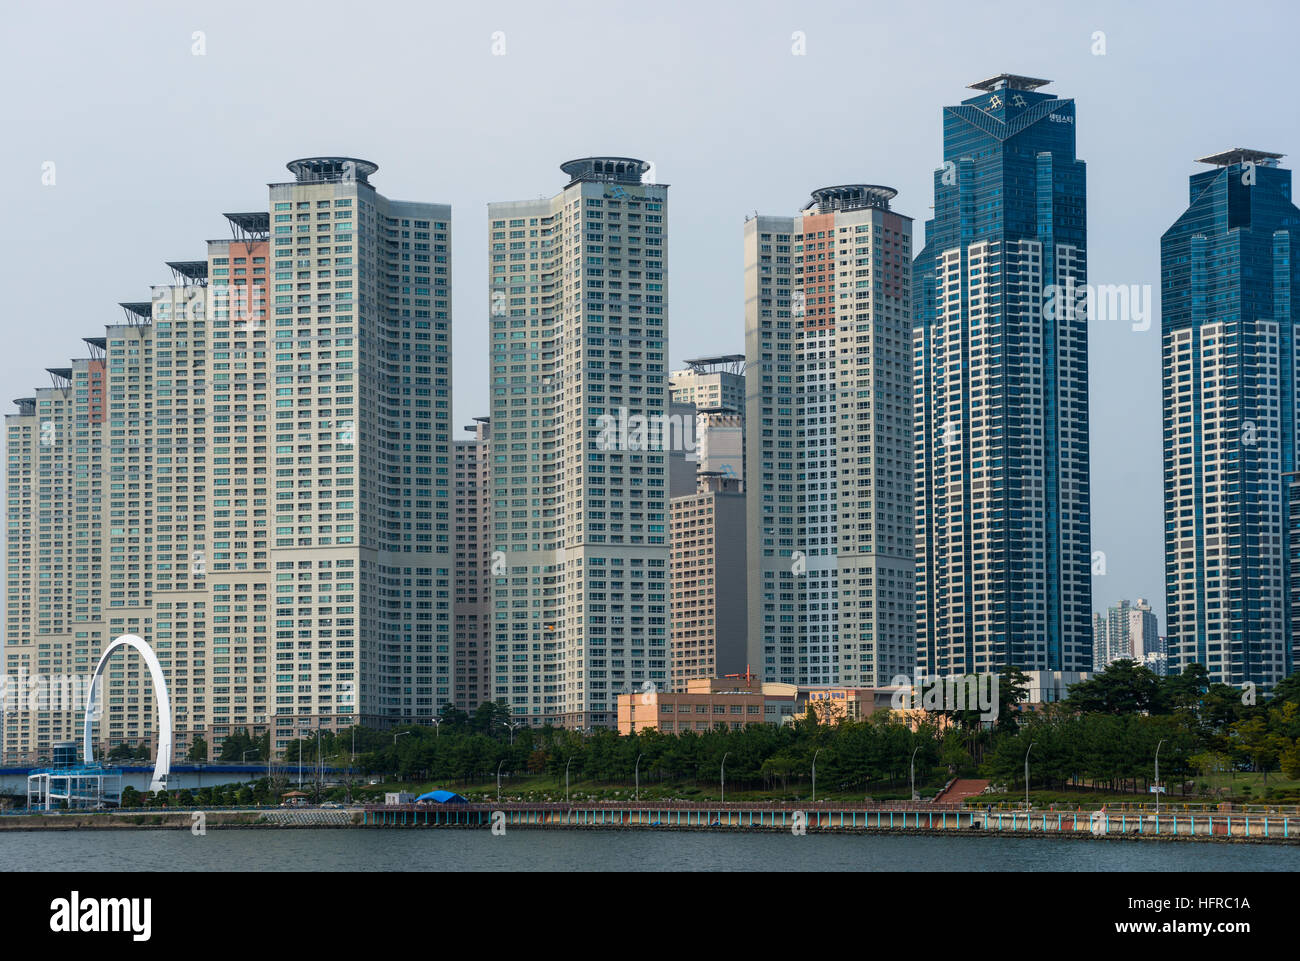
[913,74,1092,675]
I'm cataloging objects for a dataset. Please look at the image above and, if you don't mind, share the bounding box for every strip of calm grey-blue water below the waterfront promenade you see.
[0,828,1300,871]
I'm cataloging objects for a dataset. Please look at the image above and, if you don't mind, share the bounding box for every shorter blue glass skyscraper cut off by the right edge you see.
[1160,147,1300,688]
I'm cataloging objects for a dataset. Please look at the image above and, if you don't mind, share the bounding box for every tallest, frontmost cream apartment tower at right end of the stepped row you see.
[263,157,452,743]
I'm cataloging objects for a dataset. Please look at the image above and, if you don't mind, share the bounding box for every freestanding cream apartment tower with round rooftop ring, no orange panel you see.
[488,157,668,728]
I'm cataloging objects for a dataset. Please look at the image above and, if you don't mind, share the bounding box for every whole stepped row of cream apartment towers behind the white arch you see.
[4,157,451,759]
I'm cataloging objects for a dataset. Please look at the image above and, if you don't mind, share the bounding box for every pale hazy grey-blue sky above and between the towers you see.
[0,0,1300,629]
